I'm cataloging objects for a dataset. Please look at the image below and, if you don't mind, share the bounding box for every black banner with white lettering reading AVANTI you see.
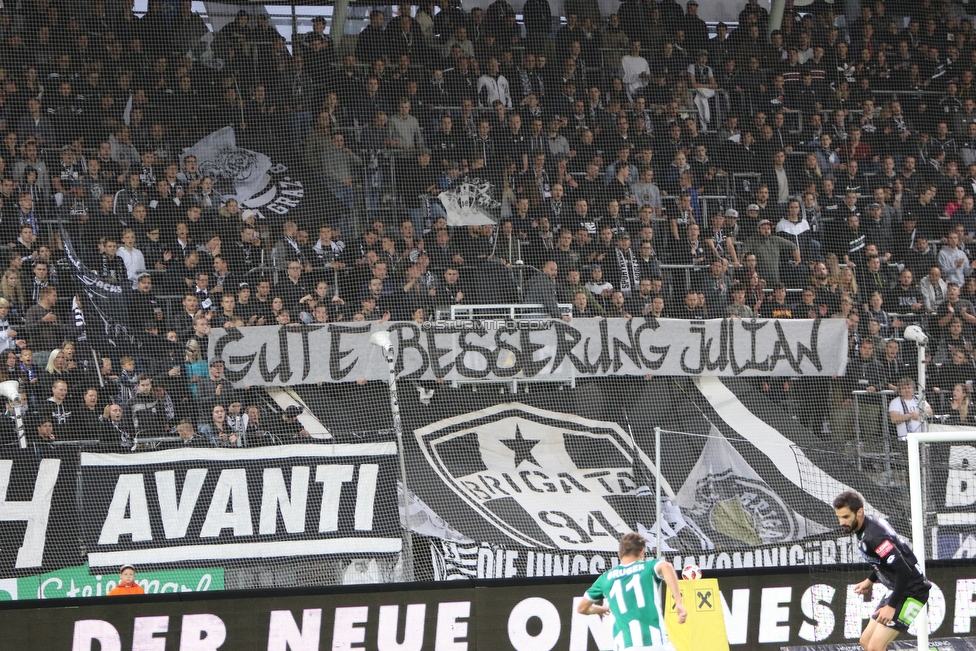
[81,443,401,568]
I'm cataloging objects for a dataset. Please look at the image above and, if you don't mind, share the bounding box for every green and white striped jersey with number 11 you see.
[586,558,667,649]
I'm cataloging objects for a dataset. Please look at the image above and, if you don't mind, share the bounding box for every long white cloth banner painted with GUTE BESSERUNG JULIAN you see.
[209,318,847,386]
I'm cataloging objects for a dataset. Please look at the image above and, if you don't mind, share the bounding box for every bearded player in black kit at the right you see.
[834,491,932,651]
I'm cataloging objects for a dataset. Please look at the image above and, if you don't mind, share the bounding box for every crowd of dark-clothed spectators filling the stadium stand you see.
[0,0,976,446]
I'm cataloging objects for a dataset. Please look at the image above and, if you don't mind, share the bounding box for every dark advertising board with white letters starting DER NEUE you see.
[0,563,976,651]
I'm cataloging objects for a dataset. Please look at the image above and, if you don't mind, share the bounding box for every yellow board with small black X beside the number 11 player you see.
[664,579,729,651]
